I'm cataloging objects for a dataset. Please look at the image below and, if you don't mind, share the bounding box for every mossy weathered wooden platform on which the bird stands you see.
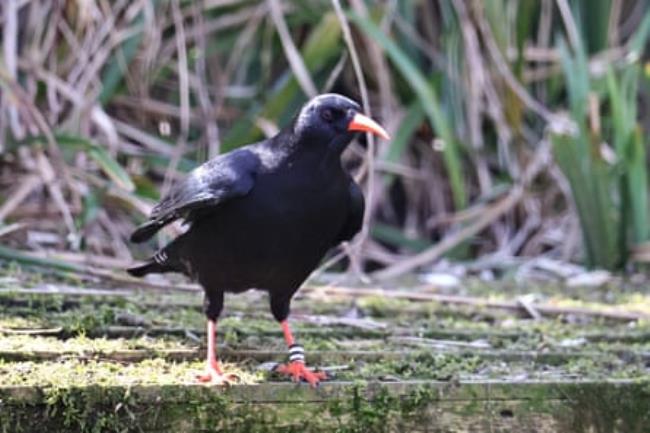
[0,266,650,432]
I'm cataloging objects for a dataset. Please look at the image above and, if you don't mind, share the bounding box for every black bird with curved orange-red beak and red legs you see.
[128,94,389,386]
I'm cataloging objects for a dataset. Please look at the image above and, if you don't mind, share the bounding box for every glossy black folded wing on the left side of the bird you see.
[131,148,260,242]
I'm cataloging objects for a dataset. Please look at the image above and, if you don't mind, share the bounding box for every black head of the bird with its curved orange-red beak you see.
[293,93,389,151]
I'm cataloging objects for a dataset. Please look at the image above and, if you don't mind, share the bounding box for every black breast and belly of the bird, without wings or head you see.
[178,148,349,291]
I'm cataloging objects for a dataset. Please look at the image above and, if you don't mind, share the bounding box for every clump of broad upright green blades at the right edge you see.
[553,11,650,269]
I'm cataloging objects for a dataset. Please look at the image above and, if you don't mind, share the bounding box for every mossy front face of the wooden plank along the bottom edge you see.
[0,380,650,433]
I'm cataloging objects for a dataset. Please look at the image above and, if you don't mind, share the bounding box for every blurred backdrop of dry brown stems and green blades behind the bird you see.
[0,0,650,276]
